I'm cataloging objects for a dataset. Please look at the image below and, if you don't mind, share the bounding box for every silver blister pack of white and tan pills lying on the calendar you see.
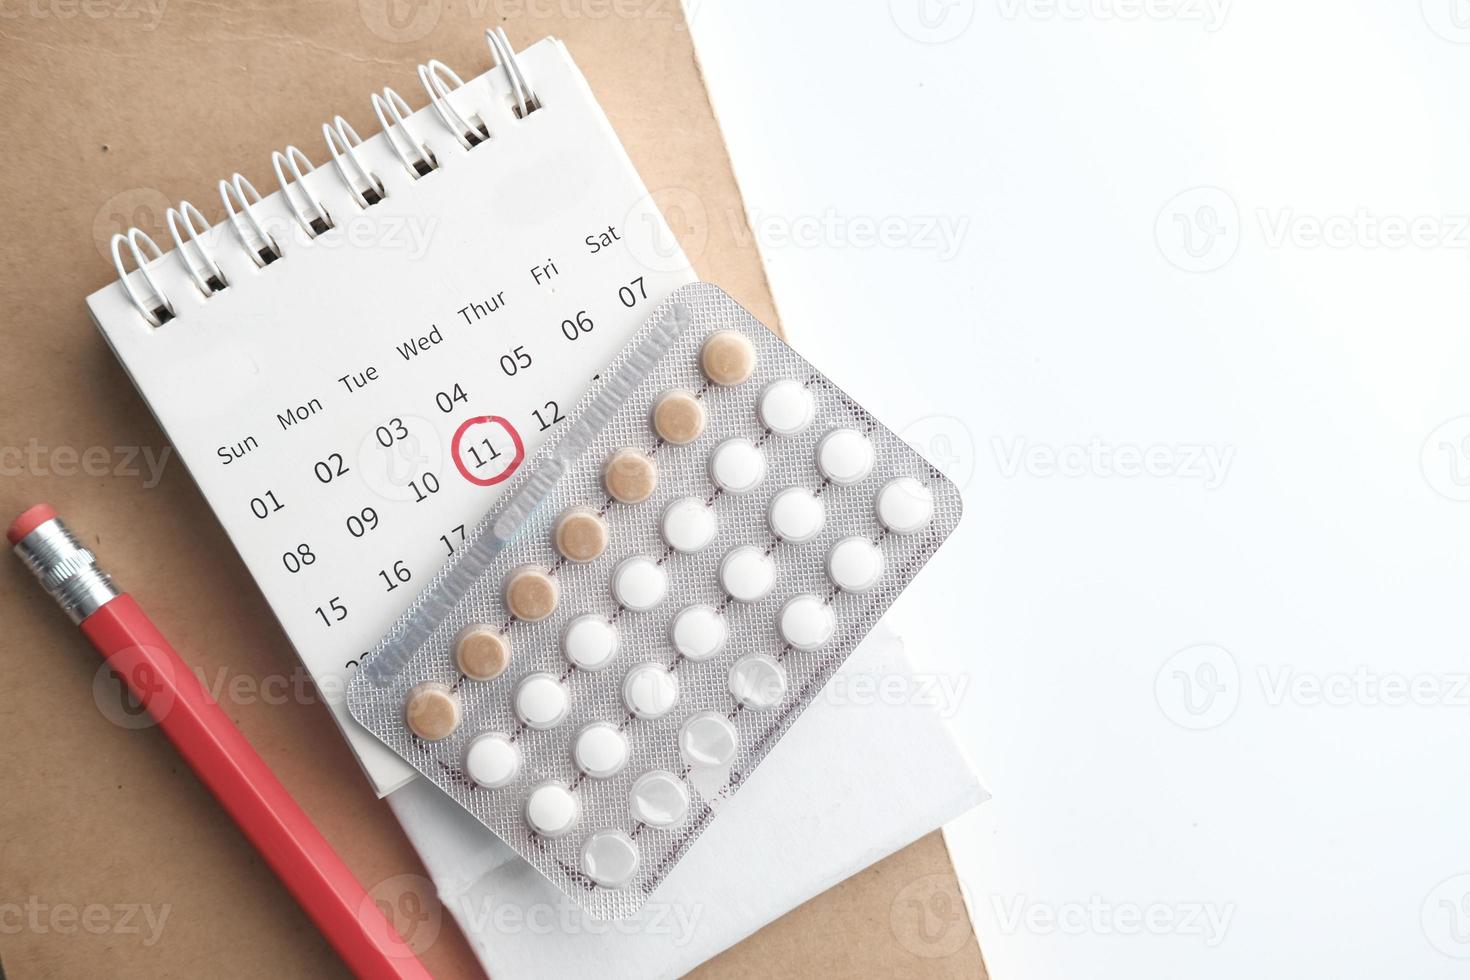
[348,282,961,918]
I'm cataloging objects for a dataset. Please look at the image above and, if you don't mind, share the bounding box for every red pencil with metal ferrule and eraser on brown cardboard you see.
[9,504,429,980]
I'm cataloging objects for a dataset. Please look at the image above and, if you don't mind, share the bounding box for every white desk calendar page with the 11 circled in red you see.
[88,40,694,793]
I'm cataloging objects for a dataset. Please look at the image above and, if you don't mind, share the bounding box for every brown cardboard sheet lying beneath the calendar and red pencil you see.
[0,0,983,977]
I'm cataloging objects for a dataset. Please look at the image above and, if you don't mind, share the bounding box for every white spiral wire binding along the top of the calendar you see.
[112,28,541,328]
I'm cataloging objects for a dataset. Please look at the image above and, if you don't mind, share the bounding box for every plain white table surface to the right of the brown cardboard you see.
[685,0,1470,980]
